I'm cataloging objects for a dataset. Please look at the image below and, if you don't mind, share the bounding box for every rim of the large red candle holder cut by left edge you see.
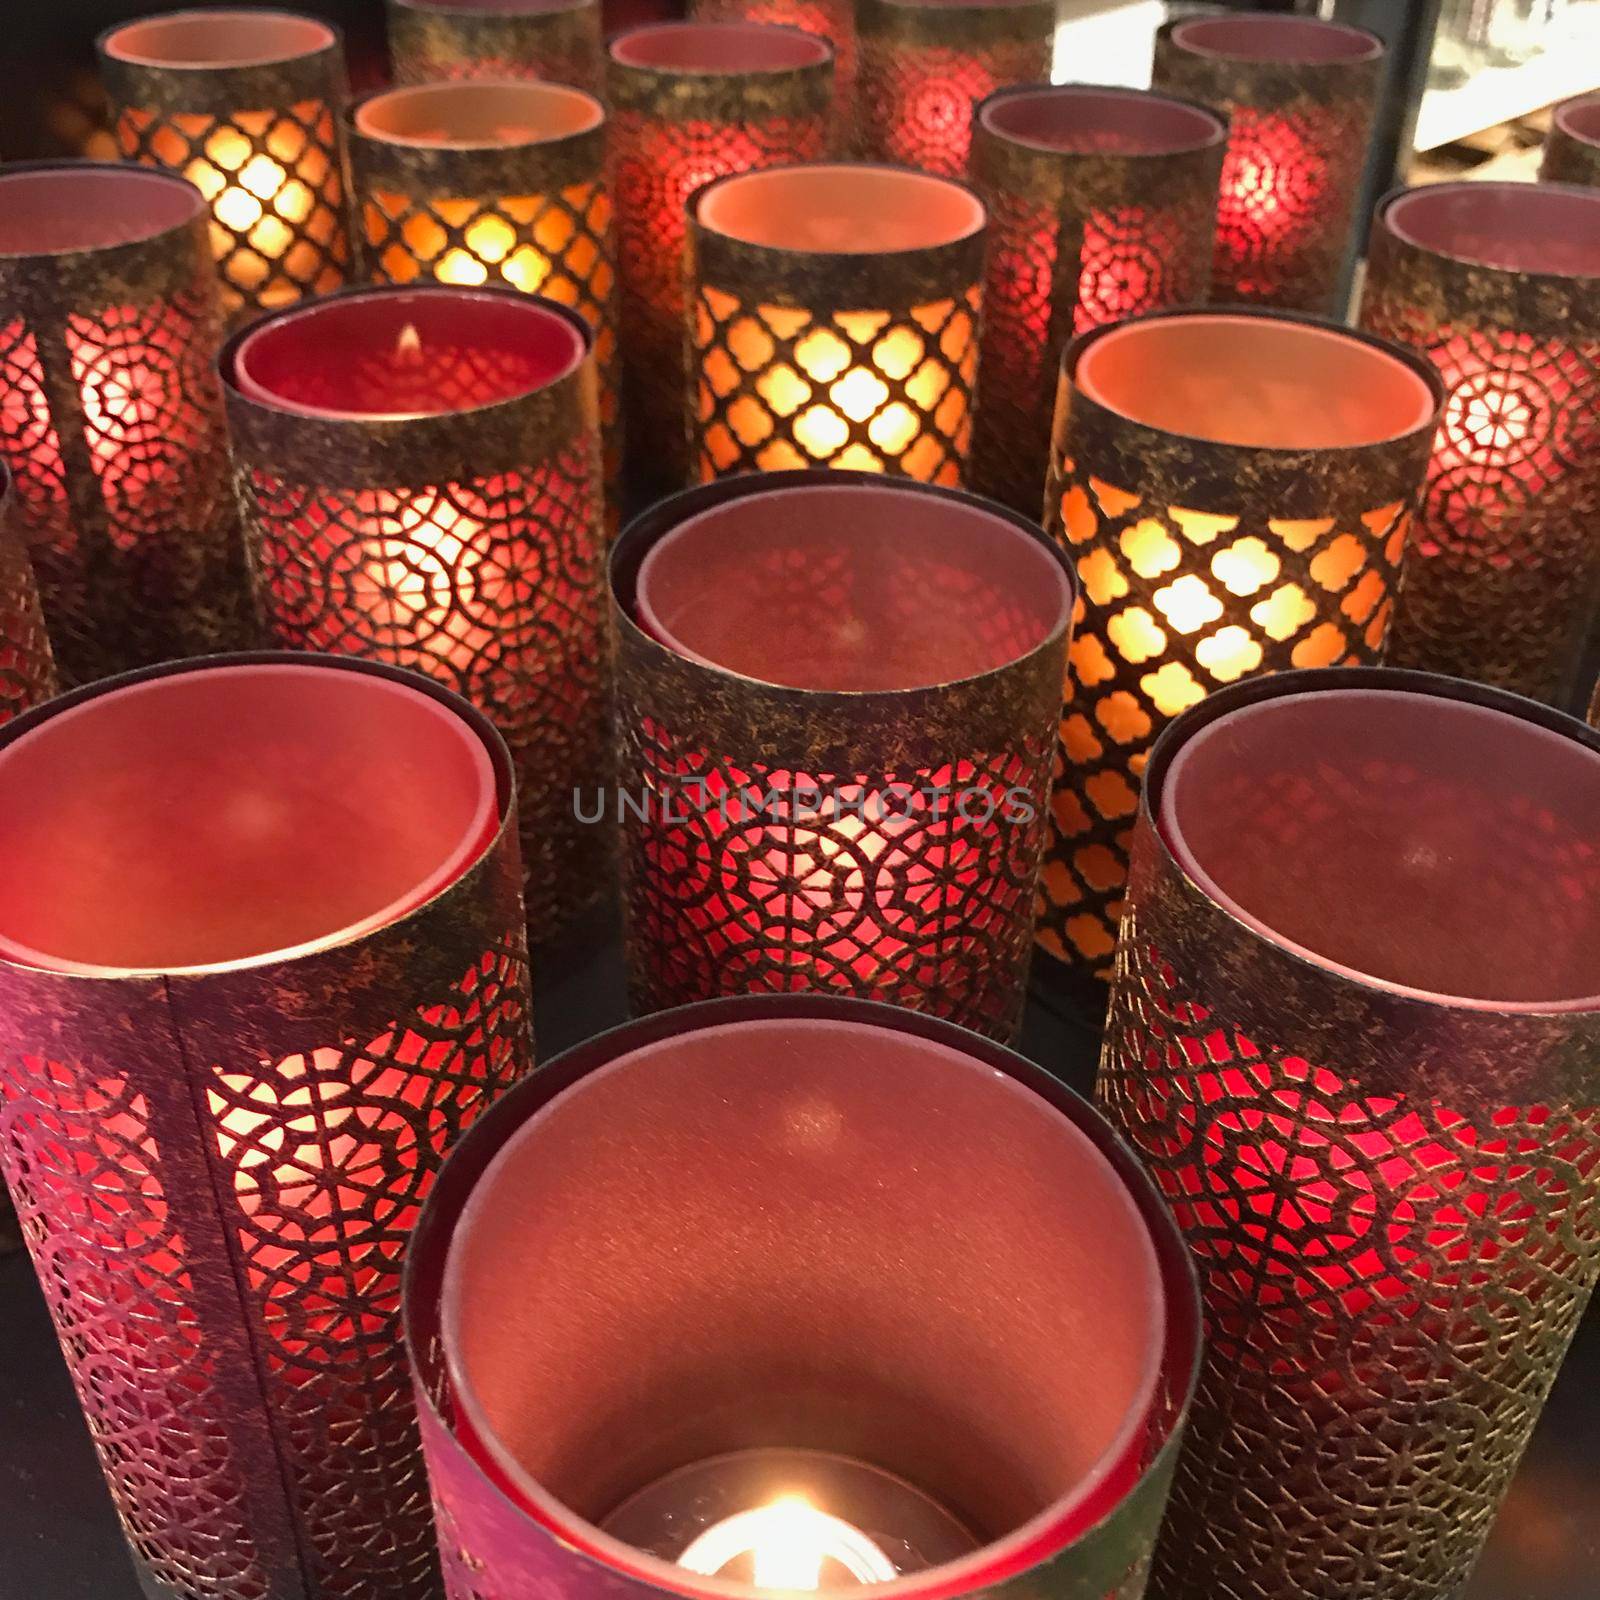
[0,650,517,982]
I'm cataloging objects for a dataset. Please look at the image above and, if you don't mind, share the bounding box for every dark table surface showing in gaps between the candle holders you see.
[0,936,1600,1600]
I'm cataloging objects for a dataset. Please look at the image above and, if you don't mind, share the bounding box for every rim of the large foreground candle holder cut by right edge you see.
[1139,667,1600,1019]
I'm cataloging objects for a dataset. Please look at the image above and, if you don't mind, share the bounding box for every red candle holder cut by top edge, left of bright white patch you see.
[856,0,1056,178]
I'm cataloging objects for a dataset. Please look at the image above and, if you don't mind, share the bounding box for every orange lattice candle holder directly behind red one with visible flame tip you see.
[350,82,621,501]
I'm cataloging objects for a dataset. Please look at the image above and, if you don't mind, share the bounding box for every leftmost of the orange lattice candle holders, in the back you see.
[99,10,350,320]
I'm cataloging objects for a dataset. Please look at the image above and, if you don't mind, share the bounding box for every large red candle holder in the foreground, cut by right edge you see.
[1099,670,1600,1600]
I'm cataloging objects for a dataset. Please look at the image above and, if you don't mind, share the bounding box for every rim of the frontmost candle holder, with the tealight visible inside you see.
[402,992,1202,1600]
